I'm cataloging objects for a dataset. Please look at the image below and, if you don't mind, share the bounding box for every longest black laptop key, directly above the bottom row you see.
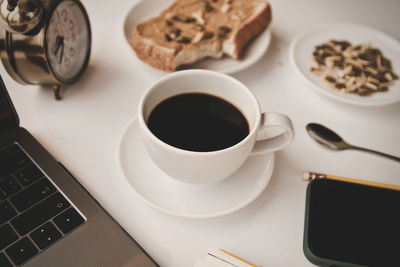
[11,193,70,235]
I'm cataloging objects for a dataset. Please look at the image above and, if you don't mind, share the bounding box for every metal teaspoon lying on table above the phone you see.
[306,123,400,162]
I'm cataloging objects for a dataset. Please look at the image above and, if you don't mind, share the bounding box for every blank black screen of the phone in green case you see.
[307,179,400,266]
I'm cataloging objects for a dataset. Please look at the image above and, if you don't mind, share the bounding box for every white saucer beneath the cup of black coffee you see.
[118,118,274,218]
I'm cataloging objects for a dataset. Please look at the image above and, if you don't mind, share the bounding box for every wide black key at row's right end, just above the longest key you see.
[10,179,56,211]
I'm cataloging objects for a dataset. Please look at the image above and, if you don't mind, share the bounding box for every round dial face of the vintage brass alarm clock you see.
[45,0,91,83]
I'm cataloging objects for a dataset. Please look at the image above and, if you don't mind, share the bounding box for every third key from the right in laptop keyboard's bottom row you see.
[6,237,38,265]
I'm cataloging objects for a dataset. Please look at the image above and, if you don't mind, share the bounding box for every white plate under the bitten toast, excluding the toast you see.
[124,0,271,74]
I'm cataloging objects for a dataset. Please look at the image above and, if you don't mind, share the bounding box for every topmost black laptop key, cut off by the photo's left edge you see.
[0,145,31,179]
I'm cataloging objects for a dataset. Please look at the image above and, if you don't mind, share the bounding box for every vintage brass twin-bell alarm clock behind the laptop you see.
[0,0,91,99]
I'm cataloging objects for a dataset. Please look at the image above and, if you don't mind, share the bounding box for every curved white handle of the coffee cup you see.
[250,112,294,155]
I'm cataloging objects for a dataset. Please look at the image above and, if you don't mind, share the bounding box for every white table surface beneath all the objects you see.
[0,0,400,267]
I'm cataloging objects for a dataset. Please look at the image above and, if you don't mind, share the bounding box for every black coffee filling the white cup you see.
[147,93,249,152]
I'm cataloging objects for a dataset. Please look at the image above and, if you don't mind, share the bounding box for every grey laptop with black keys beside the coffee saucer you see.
[0,77,159,267]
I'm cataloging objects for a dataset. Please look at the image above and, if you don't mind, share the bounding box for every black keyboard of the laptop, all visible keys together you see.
[0,144,85,267]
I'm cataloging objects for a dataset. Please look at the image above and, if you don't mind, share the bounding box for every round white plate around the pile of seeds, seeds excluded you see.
[290,23,400,106]
